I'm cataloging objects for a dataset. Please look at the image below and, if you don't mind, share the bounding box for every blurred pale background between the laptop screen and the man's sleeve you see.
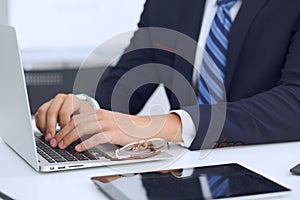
[0,0,145,113]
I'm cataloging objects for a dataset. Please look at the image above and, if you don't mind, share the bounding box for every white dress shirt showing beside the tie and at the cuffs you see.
[80,0,242,147]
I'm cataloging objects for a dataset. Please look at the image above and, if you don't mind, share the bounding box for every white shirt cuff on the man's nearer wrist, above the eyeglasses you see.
[170,110,196,148]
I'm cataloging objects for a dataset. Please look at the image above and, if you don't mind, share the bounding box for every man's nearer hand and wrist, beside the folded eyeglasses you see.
[50,109,182,152]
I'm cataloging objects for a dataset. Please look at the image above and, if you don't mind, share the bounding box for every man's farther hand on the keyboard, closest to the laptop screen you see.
[35,94,93,141]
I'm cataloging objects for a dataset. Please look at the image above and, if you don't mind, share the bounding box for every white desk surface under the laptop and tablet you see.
[0,136,300,200]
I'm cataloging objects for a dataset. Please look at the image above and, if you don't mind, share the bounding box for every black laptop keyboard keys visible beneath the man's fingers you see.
[35,136,111,163]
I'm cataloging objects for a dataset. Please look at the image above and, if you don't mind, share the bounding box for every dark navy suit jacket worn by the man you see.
[96,0,300,149]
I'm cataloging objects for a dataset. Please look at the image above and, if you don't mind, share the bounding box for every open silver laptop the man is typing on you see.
[0,26,178,172]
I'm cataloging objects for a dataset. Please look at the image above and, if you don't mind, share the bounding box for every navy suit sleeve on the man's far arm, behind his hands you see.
[95,0,177,114]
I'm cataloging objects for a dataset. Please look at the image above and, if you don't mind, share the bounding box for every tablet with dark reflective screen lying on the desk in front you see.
[91,163,290,200]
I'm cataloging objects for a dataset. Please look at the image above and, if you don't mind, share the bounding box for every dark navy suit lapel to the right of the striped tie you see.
[225,0,268,93]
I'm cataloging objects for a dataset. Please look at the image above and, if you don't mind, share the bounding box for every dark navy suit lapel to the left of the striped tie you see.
[169,0,205,109]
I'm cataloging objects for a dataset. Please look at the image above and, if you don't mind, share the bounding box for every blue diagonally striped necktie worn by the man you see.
[198,0,237,104]
